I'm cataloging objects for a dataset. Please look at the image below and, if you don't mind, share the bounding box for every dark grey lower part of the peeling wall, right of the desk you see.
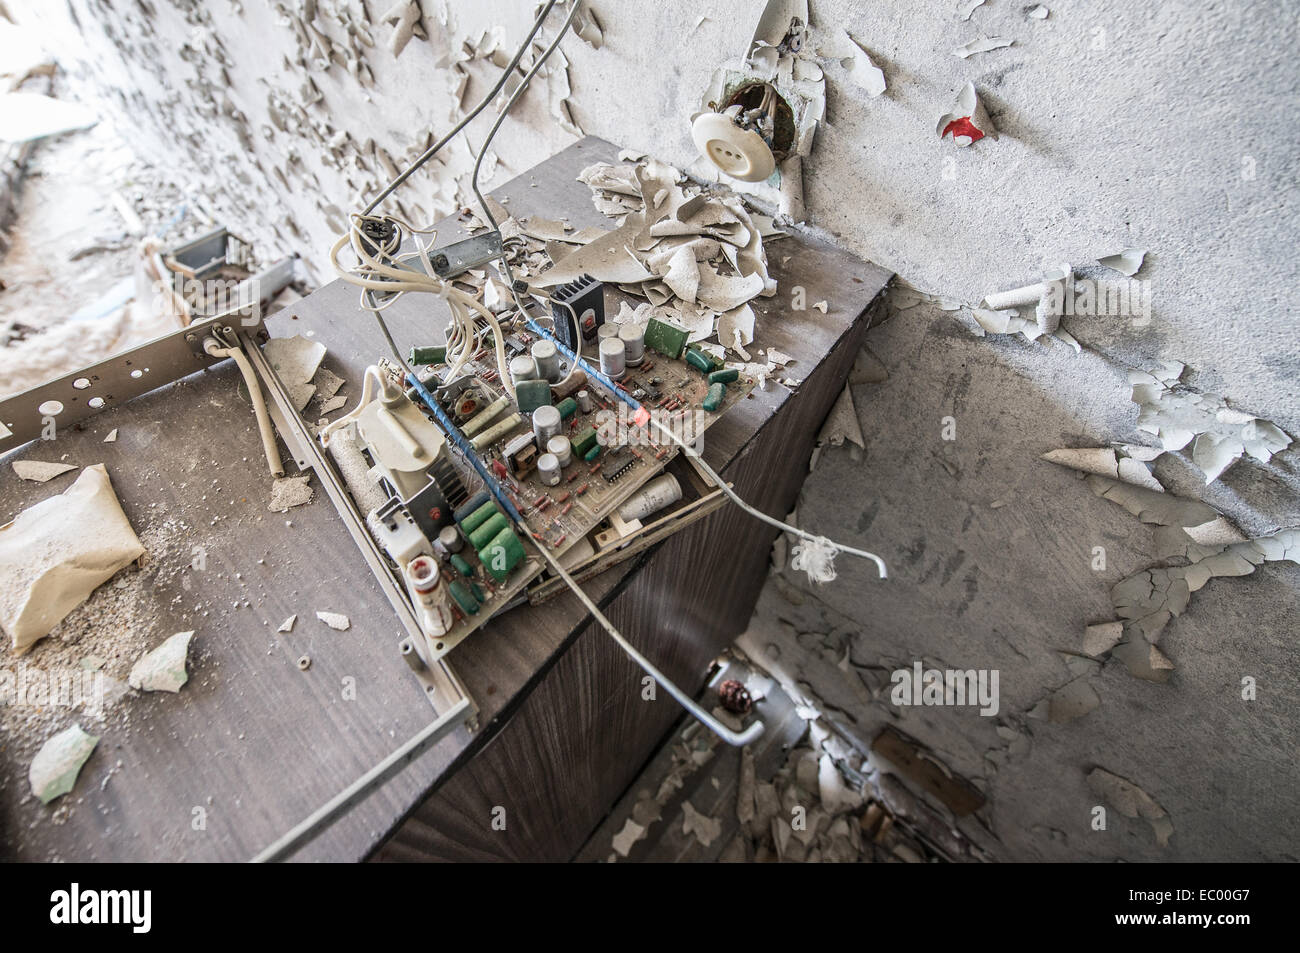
[746,289,1300,861]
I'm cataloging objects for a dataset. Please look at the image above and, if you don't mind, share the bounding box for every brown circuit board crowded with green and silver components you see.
[400,321,757,659]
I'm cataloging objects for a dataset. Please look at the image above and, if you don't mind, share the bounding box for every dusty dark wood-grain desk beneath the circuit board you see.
[0,138,889,861]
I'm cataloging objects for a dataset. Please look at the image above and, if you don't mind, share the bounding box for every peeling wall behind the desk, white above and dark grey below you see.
[22,0,1300,859]
